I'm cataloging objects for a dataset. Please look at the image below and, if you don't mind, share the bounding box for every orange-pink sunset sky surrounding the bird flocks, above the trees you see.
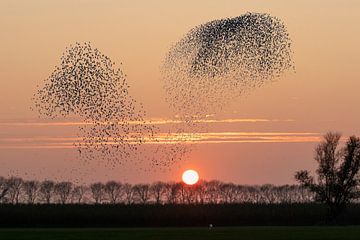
[0,0,360,184]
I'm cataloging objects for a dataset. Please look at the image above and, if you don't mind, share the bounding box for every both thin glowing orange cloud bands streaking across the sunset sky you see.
[0,116,321,149]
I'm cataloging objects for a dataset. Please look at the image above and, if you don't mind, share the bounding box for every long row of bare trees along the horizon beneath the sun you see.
[0,176,315,204]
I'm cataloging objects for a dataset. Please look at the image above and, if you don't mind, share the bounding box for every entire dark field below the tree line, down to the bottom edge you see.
[0,204,360,240]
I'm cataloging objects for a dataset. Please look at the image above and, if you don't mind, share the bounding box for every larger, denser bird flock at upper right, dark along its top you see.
[162,13,293,117]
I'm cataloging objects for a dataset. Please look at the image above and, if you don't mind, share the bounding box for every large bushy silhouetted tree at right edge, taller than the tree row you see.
[295,132,360,220]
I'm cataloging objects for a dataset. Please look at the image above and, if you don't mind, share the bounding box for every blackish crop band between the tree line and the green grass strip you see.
[0,204,360,227]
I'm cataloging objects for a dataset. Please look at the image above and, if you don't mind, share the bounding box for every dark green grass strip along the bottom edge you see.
[0,226,360,240]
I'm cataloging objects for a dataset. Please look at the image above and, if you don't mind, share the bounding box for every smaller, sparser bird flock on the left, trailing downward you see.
[34,43,155,165]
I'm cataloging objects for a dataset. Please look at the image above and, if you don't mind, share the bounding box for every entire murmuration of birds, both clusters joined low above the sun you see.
[34,13,293,179]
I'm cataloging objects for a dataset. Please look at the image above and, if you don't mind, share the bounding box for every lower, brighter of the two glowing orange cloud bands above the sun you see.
[0,132,321,149]
